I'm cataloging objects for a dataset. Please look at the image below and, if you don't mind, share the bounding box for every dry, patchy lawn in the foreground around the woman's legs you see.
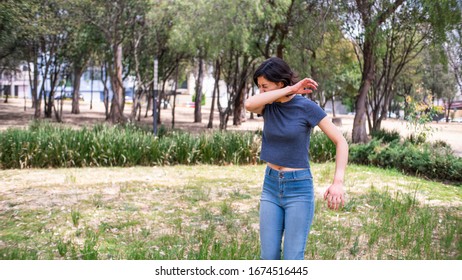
[0,163,462,260]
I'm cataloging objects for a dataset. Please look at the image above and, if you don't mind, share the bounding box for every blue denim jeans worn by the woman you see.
[260,167,314,260]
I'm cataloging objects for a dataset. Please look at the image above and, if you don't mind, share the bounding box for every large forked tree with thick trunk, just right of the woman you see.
[347,0,460,143]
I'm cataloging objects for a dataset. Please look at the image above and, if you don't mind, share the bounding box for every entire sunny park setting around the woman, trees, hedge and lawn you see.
[0,0,462,260]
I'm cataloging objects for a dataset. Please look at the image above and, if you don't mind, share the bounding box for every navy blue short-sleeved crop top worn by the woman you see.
[260,95,326,168]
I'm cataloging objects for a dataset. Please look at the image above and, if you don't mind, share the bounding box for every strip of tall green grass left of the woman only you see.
[0,123,260,169]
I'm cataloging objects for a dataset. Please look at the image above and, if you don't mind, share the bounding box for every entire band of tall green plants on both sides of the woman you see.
[0,122,462,184]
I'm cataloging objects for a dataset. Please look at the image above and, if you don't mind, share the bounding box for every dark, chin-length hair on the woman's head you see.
[253,57,297,87]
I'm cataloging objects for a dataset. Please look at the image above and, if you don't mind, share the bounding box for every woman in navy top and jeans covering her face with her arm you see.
[245,57,348,259]
